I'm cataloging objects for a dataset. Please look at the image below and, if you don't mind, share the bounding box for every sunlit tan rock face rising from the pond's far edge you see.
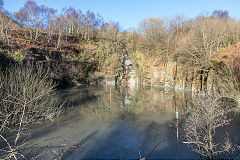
[118,57,215,92]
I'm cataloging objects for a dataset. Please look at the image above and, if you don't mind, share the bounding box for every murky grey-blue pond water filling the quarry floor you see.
[20,87,240,160]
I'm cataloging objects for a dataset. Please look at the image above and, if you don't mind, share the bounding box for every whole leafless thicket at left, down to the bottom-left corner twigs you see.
[0,62,62,159]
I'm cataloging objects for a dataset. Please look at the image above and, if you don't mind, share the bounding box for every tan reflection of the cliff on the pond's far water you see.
[63,88,191,121]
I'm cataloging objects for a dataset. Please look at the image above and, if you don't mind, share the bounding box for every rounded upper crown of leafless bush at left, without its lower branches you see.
[0,62,61,133]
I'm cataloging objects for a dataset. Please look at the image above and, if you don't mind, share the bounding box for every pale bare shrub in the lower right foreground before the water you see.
[184,97,237,159]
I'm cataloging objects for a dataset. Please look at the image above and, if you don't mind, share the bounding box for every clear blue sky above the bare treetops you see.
[4,0,240,29]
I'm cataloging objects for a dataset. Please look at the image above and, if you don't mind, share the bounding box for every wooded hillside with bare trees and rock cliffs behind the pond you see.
[0,2,240,93]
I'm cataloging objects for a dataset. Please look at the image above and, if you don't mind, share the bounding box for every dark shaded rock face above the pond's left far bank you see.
[7,48,97,88]
